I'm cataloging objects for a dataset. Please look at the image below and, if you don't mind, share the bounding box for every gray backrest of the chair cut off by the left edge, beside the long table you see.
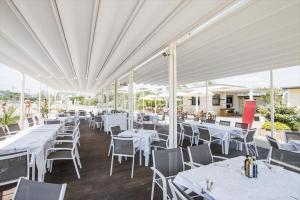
[0,151,29,186]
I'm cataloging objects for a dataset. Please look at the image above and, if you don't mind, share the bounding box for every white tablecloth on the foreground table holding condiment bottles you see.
[174,156,300,200]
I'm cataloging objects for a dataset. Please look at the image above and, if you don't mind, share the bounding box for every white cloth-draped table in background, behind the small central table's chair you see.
[102,113,127,132]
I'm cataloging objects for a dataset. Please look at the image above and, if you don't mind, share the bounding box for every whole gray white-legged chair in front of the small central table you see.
[110,137,137,178]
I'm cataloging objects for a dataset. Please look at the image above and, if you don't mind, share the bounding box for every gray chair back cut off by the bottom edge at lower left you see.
[13,178,67,200]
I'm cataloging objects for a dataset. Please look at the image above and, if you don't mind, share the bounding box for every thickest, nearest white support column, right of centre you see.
[169,43,177,148]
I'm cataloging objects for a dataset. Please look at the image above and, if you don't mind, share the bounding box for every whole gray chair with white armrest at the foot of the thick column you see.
[151,148,190,200]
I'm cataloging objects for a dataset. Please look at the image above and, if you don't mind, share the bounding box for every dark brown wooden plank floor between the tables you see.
[0,121,267,200]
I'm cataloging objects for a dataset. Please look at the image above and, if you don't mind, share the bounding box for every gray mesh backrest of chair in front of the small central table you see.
[113,137,135,155]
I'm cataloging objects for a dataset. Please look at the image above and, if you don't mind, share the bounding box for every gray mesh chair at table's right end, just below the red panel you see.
[231,128,259,157]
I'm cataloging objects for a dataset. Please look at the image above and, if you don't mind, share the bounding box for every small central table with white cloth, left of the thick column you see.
[119,129,159,166]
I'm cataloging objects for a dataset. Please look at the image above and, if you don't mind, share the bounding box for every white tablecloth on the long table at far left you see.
[0,124,61,181]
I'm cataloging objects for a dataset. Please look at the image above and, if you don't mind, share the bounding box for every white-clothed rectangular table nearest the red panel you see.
[184,121,243,154]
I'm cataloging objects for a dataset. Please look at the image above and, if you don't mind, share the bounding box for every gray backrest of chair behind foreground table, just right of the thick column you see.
[188,144,213,165]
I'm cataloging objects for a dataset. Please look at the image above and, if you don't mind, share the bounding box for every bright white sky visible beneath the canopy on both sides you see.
[0,63,300,94]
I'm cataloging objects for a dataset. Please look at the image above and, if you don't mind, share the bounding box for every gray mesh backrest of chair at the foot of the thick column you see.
[152,148,184,177]
